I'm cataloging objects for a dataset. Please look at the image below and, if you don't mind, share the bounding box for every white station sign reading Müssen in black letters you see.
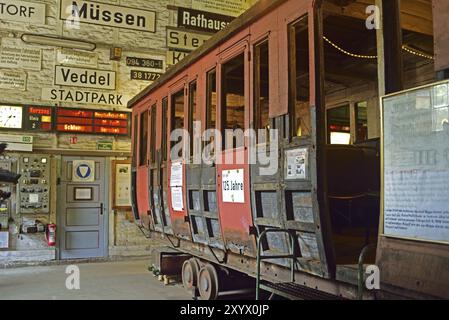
[60,0,156,32]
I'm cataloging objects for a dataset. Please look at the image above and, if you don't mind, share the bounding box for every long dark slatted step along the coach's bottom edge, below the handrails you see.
[260,281,344,300]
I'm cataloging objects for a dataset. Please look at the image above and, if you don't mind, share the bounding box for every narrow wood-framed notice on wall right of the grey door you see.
[112,160,131,210]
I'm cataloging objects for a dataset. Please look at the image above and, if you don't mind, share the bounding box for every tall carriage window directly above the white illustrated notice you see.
[289,16,311,137]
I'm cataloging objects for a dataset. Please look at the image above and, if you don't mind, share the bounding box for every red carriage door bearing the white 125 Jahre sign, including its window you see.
[217,40,256,256]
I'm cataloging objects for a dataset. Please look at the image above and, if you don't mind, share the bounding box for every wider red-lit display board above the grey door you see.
[56,108,129,135]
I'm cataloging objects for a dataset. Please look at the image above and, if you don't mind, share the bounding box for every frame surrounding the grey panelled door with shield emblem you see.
[56,154,111,260]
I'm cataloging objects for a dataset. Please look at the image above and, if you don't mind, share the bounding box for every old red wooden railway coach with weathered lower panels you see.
[129,0,449,299]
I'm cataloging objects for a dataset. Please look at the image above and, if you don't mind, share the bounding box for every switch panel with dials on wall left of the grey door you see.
[17,155,50,214]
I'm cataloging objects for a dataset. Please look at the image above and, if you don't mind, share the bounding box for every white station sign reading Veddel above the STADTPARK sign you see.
[55,66,115,90]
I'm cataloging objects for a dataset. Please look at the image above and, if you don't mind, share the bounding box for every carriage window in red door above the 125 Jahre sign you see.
[221,53,245,148]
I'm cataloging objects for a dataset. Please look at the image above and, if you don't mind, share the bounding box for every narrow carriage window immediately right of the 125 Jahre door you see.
[254,41,270,142]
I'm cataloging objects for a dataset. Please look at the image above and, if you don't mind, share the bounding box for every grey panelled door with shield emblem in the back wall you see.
[59,157,108,259]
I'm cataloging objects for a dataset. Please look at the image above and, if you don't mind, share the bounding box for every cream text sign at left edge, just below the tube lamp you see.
[0,44,42,71]
